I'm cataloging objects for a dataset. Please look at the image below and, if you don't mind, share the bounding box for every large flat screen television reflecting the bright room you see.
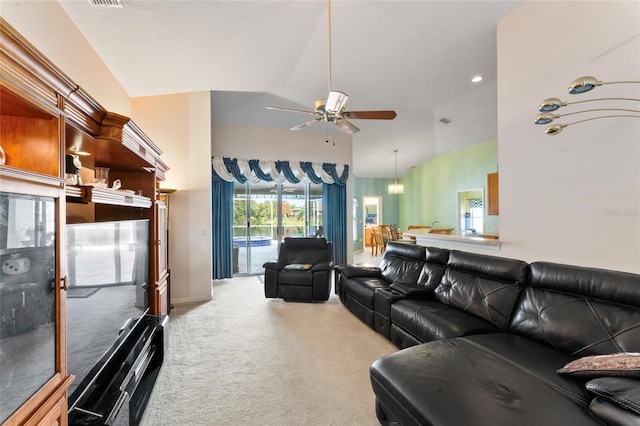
[66,219,150,404]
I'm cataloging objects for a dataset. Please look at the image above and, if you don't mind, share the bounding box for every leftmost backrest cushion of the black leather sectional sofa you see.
[380,242,426,283]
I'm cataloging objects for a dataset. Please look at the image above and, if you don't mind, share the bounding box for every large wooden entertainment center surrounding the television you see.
[0,18,169,425]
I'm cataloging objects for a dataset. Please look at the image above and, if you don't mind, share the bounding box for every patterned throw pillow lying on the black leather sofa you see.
[558,352,640,377]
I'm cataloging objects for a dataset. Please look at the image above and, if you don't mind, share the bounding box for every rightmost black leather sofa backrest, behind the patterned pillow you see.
[509,262,640,357]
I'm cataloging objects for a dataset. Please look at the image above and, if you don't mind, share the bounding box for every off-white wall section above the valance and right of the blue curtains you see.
[211,112,354,261]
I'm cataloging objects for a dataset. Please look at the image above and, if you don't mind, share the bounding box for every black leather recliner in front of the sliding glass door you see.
[263,237,333,302]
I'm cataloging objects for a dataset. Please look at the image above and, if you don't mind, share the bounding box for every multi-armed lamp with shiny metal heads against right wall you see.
[534,76,640,135]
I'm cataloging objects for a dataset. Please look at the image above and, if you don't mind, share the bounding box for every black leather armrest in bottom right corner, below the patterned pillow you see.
[586,377,640,425]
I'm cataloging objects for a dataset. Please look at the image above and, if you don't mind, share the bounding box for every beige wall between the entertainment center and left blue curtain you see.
[132,92,212,303]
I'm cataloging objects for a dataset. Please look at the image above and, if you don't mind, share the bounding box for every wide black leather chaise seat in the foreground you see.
[370,333,601,426]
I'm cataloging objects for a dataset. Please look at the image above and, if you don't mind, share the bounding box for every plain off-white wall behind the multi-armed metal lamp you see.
[498,1,640,273]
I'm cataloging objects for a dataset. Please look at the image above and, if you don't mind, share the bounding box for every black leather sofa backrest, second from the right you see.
[434,250,528,331]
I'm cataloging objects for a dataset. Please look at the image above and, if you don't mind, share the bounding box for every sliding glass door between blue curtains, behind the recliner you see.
[233,182,322,275]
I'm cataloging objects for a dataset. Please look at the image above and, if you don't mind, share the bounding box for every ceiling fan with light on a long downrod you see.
[267,0,396,134]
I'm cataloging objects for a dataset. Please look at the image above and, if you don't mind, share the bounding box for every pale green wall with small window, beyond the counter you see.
[400,140,499,233]
